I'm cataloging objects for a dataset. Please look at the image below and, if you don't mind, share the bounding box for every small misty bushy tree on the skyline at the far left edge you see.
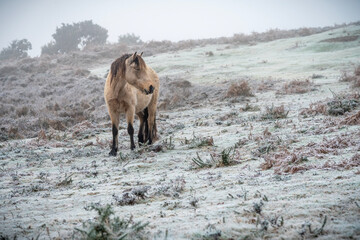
[0,39,32,60]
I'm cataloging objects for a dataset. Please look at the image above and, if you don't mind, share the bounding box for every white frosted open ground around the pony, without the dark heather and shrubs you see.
[0,23,360,239]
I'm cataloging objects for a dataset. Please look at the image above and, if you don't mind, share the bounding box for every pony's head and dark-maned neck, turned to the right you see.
[111,52,155,94]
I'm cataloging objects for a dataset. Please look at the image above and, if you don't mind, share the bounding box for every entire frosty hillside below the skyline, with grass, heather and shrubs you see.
[0,23,360,239]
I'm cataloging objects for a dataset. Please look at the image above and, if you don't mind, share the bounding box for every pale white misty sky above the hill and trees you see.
[0,0,360,56]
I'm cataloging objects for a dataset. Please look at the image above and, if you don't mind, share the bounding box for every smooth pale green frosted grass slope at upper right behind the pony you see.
[139,26,360,83]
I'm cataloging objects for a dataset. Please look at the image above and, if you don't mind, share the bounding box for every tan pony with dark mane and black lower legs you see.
[104,52,159,156]
